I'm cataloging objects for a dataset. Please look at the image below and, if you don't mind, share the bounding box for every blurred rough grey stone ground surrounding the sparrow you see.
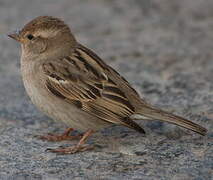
[0,0,213,180]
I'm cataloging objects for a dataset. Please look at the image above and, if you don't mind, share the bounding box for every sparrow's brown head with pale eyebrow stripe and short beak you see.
[8,16,76,56]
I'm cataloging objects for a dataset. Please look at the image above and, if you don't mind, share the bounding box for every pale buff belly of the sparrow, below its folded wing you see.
[24,80,110,131]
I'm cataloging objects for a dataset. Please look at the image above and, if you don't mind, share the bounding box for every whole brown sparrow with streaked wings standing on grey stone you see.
[8,16,207,154]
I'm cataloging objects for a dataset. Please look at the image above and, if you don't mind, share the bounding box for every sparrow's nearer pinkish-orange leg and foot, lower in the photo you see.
[47,130,94,154]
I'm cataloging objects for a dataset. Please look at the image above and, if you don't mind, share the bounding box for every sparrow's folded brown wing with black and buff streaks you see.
[42,46,144,133]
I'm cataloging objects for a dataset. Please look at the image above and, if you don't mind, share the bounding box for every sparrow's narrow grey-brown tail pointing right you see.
[130,105,207,136]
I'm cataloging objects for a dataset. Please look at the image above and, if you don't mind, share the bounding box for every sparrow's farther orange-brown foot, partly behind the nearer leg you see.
[37,128,82,141]
